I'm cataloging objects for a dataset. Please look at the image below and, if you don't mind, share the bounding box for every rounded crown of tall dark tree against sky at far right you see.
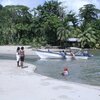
[79,4,100,27]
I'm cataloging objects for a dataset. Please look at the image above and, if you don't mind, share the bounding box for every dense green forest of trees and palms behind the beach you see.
[0,0,100,49]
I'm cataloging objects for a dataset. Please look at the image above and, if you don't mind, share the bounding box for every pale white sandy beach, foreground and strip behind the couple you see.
[0,46,100,100]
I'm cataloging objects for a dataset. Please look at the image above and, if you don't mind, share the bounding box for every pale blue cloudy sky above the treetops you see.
[0,0,100,13]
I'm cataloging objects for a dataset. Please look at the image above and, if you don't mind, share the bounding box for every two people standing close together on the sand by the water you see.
[16,46,25,68]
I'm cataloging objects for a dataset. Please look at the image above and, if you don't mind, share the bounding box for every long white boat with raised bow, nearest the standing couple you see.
[36,50,65,59]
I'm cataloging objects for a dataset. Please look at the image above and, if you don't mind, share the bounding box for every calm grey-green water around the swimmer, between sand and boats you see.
[0,50,100,86]
